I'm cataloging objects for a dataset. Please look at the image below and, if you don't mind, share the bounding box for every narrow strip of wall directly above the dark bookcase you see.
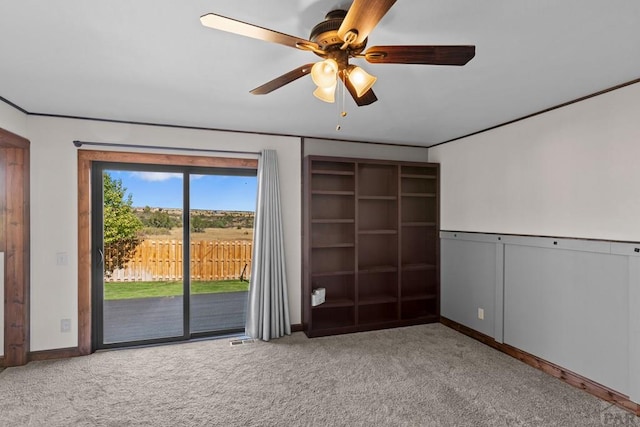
[304,138,428,162]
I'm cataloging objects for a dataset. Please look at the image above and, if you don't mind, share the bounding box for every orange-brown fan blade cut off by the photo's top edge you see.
[338,0,396,45]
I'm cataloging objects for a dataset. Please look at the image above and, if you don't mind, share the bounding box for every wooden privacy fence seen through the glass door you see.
[104,240,252,282]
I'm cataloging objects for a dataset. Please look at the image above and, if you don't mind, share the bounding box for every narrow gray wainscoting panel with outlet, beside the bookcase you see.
[440,233,502,340]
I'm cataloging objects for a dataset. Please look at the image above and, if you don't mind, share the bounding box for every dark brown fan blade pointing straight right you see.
[364,45,476,65]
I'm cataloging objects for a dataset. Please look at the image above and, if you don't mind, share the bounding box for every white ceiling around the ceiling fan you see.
[0,0,640,146]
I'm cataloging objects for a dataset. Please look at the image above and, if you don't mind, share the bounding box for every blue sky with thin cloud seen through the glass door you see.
[108,170,258,212]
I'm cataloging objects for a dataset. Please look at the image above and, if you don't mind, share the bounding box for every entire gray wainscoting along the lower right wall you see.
[440,231,640,403]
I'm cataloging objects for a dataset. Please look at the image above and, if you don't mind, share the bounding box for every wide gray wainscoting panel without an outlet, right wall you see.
[504,244,630,394]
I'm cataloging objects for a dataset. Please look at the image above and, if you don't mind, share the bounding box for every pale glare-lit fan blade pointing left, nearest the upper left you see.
[200,13,319,50]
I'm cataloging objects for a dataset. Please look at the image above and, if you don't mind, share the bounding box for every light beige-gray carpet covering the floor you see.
[0,324,635,427]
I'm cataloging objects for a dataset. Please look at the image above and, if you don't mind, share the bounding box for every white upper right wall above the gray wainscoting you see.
[429,84,640,241]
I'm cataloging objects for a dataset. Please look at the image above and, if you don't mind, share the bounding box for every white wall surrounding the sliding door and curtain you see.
[28,116,301,351]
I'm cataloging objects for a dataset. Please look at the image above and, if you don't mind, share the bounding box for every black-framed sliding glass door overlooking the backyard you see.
[92,162,257,349]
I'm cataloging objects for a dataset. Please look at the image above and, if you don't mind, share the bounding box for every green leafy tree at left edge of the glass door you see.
[102,172,143,275]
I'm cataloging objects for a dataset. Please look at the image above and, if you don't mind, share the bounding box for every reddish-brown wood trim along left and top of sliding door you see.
[78,150,258,355]
